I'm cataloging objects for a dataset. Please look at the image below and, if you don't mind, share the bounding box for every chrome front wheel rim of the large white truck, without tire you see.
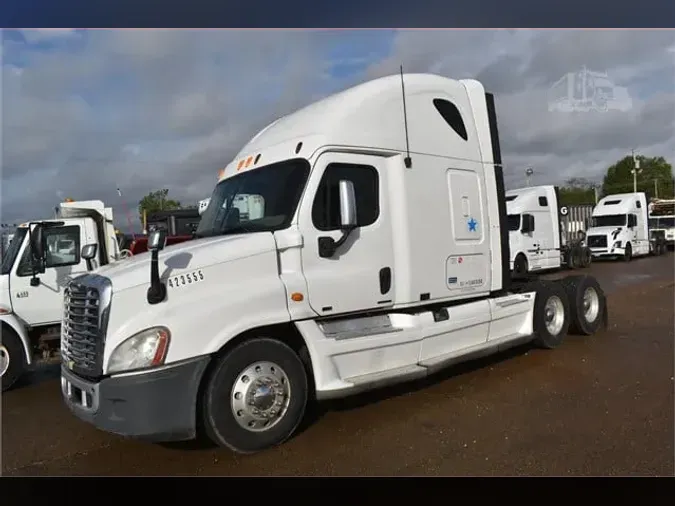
[230,362,291,432]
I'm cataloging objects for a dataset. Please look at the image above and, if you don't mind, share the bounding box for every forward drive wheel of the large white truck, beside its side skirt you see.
[532,281,570,350]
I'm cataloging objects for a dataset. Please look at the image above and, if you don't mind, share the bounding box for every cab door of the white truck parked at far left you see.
[10,223,87,326]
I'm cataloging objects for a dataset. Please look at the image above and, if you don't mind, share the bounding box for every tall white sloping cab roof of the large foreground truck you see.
[219,74,493,185]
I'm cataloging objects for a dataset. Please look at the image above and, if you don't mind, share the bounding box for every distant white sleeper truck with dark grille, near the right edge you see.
[586,192,667,262]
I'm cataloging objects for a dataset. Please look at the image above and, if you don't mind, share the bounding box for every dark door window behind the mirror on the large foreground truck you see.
[312,163,380,231]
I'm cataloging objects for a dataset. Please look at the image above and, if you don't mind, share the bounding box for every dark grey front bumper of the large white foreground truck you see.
[61,356,210,441]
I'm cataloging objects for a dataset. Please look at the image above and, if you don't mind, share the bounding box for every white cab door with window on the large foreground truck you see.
[298,152,395,316]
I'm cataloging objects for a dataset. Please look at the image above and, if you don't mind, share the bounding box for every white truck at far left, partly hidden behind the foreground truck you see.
[0,200,119,391]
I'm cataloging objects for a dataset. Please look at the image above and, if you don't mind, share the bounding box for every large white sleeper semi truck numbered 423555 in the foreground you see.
[56,74,607,453]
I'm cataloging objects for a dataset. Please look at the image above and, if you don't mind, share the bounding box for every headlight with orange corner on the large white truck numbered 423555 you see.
[108,327,171,373]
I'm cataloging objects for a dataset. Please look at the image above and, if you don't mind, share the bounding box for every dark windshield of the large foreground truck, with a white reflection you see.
[196,159,309,237]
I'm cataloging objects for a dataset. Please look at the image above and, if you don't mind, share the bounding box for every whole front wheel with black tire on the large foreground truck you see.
[202,338,309,453]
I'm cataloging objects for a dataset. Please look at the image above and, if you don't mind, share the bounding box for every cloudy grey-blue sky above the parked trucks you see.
[0,30,675,231]
